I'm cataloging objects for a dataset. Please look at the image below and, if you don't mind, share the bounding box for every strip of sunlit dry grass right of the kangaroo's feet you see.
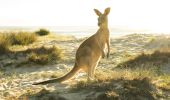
[75,69,155,89]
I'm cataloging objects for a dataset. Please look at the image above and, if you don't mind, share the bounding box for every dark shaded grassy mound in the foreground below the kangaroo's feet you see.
[17,78,170,100]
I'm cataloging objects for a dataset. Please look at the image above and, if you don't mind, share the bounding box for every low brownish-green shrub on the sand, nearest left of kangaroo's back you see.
[26,46,62,65]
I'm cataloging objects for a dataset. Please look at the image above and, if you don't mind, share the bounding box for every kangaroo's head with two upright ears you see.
[94,8,110,27]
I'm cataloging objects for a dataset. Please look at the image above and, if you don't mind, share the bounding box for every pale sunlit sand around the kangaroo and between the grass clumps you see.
[0,34,170,100]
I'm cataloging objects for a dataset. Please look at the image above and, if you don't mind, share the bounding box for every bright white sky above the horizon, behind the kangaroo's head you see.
[0,0,170,32]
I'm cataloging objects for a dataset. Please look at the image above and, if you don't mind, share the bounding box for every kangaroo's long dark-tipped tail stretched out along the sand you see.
[33,64,79,85]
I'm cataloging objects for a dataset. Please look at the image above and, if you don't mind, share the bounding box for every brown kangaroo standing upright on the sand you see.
[33,8,110,85]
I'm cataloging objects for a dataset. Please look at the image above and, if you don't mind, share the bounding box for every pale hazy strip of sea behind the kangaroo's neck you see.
[0,26,149,37]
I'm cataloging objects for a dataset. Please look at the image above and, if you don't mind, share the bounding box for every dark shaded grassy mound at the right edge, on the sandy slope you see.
[117,51,170,69]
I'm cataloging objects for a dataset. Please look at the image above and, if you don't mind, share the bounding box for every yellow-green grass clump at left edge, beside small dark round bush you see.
[0,32,37,54]
